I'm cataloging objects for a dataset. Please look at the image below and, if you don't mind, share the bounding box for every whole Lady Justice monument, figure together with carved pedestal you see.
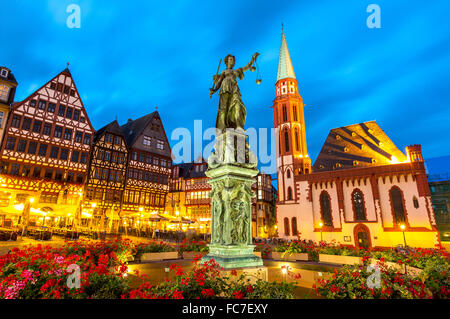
[202,53,267,279]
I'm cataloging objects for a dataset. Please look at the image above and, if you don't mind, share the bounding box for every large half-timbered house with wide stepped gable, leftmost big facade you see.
[0,68,94,228]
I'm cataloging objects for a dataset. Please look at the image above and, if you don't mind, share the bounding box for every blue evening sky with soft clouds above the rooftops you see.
[0,0,450,172]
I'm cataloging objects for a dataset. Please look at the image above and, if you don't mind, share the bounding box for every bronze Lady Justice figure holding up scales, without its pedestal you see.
[209,53,259,131]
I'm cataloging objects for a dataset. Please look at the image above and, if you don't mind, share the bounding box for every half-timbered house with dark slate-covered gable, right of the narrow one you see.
[121,111,172,226]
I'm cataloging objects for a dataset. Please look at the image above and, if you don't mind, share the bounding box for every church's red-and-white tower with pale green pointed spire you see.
[273,30,311,204]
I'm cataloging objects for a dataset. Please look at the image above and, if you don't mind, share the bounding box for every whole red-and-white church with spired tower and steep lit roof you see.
[273,32,440,247]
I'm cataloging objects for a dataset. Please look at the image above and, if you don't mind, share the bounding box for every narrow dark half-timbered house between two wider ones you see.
[83,121,128,231]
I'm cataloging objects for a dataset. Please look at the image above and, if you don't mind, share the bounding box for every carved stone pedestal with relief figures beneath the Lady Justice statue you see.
[202,130,263,269]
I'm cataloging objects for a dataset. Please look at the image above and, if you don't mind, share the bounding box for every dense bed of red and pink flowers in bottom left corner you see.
[0,241,134,299]
